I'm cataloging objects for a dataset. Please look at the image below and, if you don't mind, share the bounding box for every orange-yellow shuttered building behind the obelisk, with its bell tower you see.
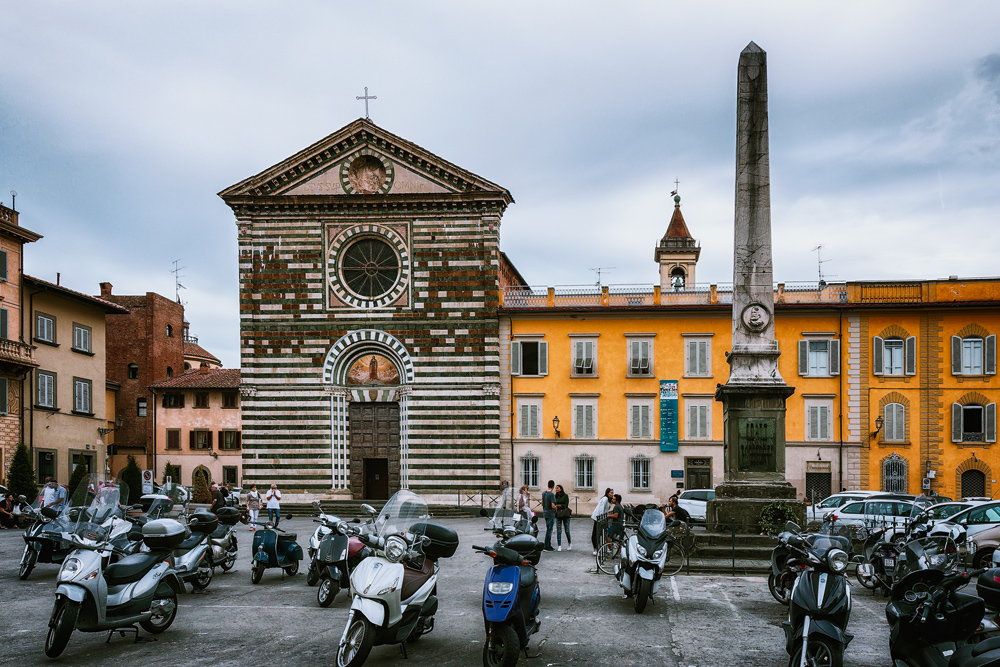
[500,197,1000,511]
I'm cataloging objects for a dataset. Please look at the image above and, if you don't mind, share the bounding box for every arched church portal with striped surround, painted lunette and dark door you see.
[323,330,413,500]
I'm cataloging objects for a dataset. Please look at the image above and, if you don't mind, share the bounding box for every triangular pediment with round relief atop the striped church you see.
[219,118,512,203]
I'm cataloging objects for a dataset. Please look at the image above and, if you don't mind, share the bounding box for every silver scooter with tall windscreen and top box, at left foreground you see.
[45,480,185,658]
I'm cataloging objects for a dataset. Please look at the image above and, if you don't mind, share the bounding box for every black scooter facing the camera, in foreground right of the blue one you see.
[781,522,854,667]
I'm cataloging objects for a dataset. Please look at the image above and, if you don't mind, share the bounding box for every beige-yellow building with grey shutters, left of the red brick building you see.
[24,275,128,484]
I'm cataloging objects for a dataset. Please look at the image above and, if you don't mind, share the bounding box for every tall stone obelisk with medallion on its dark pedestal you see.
[707,42,801,532]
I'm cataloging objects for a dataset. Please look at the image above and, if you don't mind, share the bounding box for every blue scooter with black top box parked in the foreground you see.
[472,488,543,667]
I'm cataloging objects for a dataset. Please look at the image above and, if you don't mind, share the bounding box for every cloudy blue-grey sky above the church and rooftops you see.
[0,0,1000,367]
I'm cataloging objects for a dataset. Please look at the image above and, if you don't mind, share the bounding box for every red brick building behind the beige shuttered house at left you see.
[101,283,184,474]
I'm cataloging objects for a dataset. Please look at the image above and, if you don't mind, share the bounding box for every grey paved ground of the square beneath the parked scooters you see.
[0,518,889,667]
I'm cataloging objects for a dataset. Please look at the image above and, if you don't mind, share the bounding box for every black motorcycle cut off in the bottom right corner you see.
[885,537,1000,667]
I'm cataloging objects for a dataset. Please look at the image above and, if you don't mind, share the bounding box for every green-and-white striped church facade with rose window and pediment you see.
[219,119,516,502]
